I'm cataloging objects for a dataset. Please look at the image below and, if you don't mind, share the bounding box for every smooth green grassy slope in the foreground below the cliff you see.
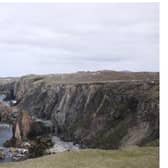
[0,147,159,168]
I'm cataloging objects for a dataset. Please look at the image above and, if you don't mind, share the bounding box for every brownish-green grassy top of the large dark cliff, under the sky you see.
[18,71,159,84]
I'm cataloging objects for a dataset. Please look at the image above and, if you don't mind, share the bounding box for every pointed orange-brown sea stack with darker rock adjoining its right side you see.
[7,110,53,148]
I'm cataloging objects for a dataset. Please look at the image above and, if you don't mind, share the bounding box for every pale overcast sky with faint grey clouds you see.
[0,3,159,77]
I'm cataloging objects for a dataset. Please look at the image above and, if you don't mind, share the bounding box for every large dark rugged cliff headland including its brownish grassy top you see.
[0,71,159,149]
